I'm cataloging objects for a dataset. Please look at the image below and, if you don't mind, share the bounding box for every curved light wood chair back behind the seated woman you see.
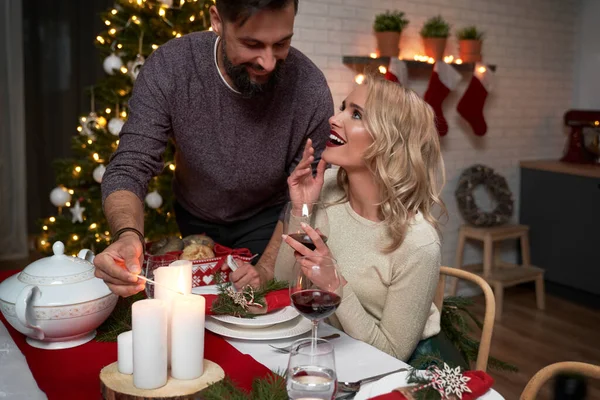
[433,267,496,372]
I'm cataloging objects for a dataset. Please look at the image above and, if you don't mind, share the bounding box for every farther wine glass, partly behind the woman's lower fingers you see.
[283,201,329,250]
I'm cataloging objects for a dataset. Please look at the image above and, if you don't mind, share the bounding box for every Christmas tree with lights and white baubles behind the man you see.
[38,0,214,254]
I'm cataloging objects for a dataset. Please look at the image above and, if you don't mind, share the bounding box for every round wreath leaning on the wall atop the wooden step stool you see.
[455,164,514,226]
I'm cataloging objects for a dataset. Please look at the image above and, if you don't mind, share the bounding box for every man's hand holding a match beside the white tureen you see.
[94,232,145,297]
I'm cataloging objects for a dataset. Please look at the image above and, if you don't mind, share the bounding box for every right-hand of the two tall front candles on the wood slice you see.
[171,294,205,379]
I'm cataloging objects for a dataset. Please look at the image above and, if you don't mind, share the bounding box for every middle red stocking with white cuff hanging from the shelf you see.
[423,61,461,136]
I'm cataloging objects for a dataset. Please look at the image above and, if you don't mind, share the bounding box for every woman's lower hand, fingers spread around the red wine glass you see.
[283,223,346,292]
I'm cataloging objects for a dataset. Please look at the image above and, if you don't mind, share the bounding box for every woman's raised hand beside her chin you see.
[288,139,327,203]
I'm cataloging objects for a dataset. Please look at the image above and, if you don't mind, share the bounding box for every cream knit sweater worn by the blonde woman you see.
[275,169,441,361]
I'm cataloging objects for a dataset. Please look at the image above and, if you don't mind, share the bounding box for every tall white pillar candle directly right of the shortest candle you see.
[131,300,167,389]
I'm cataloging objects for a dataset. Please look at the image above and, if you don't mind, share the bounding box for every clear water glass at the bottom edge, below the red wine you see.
[286,338,337,400]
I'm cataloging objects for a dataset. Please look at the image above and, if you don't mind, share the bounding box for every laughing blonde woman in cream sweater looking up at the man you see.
[275,78,445,360]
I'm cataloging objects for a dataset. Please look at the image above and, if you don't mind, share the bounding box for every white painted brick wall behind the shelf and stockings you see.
[293,0,579,272]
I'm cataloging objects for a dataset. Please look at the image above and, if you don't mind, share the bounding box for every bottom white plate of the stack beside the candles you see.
[206,316,312,340]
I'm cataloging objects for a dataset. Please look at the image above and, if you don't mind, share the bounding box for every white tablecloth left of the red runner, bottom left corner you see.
[0,322,47,400]
